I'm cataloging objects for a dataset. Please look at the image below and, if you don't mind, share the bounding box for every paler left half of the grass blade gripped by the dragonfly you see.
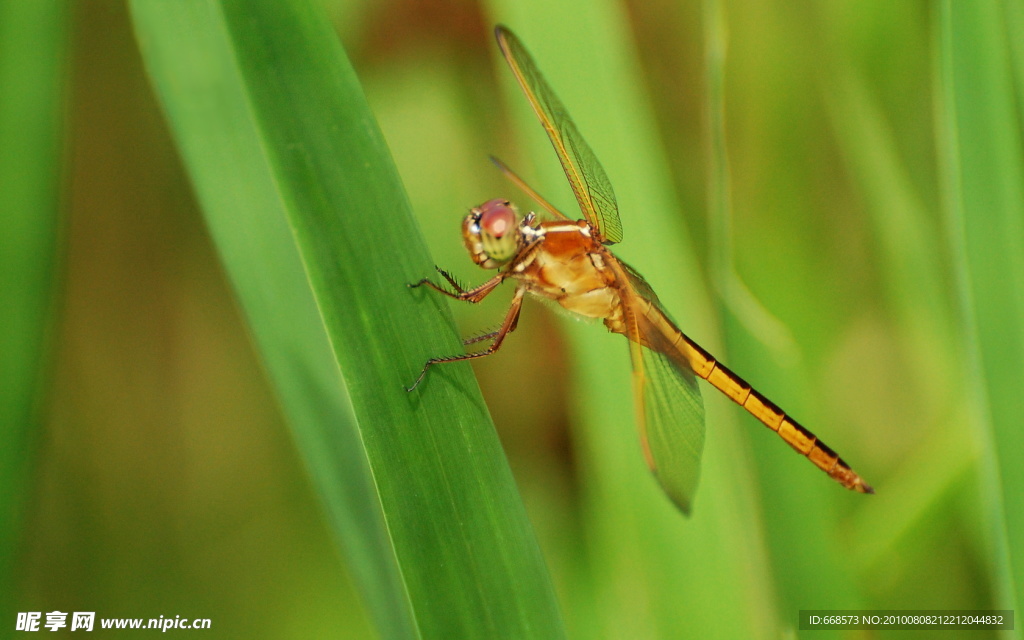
[134,3,415,637]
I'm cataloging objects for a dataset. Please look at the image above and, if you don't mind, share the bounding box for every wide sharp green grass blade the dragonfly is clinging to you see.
[132,0,561,638]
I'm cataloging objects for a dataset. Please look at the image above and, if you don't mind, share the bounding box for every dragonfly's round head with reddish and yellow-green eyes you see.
[462,199,523,269]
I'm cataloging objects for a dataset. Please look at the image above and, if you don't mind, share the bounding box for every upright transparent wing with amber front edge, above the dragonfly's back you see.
[495,26,623,245]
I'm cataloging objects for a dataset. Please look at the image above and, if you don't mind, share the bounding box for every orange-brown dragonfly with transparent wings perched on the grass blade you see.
[407,25,874,514]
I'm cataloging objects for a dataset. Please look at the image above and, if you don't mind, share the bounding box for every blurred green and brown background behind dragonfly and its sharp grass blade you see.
[0,0,1024,638]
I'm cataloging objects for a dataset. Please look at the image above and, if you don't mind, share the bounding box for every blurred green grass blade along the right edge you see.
[940,1,1024,622]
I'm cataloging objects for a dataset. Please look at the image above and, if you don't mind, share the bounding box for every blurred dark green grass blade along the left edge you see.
[0,0,68,618]
